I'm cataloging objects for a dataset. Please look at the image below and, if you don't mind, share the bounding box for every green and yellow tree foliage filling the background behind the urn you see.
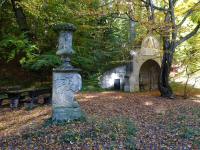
[0,0,200,81]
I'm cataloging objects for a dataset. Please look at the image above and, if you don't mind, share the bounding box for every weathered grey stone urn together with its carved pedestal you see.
[52,23,82,121]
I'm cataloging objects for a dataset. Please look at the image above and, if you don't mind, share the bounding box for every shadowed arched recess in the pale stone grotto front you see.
[139,60,160,91]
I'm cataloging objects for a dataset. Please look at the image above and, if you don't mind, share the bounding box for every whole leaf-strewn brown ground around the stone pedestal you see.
[0,92,200,149]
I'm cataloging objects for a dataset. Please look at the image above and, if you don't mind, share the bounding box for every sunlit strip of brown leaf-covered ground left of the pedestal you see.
[0,107,51,136]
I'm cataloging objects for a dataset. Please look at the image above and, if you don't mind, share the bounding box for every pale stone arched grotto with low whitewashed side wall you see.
[100,35,161,92]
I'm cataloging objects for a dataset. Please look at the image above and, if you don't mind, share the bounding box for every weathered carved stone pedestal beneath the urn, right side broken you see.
[52,69,82,121]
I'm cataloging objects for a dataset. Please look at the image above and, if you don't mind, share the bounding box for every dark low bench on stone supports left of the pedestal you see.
[0,88,51,108]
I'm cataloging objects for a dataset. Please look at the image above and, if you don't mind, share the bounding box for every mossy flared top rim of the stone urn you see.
[53,23,76,32]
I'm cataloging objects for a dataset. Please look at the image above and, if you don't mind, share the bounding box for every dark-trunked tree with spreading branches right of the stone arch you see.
[142,0,200,98]
